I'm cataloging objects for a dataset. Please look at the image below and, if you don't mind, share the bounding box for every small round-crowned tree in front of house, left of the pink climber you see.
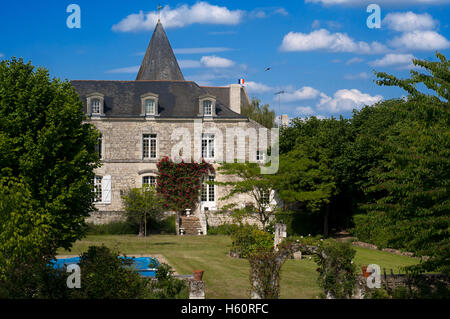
[122,186,164,236]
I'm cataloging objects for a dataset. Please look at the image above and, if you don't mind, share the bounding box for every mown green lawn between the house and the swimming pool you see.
[58,235,418,299]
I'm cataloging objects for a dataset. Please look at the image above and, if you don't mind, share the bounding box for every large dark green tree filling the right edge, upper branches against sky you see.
[355,53,450,273]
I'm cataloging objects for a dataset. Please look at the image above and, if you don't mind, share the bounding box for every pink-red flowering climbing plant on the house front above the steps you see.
[156,157,214,212]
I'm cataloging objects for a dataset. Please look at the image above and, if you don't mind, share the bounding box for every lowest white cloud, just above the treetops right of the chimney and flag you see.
[317,89,383,113]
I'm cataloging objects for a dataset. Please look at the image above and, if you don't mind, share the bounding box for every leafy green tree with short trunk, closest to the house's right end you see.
[274,117,352,236]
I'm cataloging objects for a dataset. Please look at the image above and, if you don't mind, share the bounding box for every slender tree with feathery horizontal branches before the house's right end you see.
[215,163,276,230]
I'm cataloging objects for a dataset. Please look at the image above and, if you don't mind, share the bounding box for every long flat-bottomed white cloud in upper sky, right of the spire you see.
[280,29,388,54]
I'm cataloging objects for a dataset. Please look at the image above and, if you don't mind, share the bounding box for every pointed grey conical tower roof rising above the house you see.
[136,20,184,81]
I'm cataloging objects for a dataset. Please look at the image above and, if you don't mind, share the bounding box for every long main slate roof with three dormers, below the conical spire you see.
[71,80,247,119]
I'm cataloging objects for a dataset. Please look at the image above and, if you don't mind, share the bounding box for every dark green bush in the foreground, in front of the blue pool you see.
[72,246,148,299]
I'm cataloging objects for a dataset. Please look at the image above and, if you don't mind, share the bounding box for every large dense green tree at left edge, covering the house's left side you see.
[0,58,99,255]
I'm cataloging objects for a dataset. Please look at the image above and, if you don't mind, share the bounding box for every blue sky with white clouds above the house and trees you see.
[0,0,450,117]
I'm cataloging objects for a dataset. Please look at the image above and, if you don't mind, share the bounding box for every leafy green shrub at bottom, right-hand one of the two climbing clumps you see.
[315,240,356,299]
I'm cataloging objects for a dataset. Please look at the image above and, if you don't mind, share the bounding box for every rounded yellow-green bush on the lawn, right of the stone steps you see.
[231,225,273,258]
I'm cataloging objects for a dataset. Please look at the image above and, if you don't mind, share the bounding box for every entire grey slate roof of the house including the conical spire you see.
[71,21,248,119]
